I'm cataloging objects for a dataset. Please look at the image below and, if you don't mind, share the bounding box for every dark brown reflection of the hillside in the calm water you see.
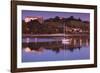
[22,38,89,53]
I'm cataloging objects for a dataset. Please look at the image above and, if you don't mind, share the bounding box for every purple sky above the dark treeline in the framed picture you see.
[22,10,90,21]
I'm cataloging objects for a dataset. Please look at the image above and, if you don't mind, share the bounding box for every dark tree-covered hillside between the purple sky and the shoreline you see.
[22,16,90,34]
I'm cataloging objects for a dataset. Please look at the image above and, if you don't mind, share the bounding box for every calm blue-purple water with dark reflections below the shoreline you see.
[22,37,90,62]
